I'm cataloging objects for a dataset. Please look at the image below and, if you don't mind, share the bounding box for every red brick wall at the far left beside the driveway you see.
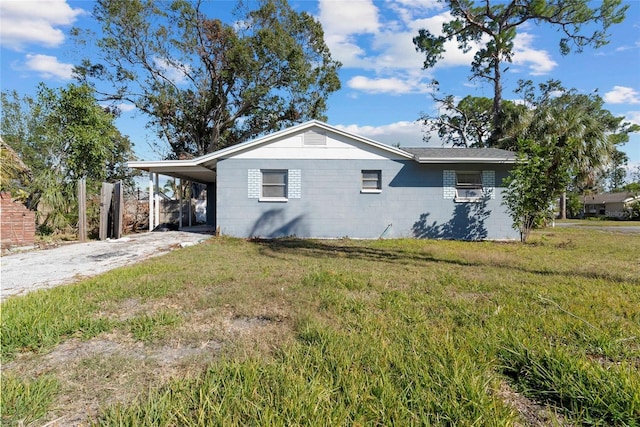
[0,192,36,249]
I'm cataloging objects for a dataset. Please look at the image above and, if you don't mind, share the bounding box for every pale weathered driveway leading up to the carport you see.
[0,228,211,301]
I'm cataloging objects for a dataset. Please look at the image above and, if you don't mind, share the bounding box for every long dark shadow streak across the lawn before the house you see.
[251,238,640,285]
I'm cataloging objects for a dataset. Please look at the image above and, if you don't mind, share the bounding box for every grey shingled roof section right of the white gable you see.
[403,147,516,163]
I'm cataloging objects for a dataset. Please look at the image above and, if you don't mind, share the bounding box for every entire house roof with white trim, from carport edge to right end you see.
[127,120,516,183]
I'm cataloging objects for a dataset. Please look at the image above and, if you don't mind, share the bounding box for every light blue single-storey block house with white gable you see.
[129,121,519,240]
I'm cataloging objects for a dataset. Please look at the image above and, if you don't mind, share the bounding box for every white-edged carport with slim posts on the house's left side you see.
[127,156,217,230]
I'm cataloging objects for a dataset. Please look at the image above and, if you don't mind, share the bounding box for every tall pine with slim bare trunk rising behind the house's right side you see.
[413,0,628,141]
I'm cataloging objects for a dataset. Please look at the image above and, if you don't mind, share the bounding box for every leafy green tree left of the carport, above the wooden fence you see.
[0,84,133,236]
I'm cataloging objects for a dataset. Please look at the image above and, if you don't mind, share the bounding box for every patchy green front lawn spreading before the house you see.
[1,227,640,426]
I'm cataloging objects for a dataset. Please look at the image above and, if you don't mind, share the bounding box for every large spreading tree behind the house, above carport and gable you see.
[76,0,340,158]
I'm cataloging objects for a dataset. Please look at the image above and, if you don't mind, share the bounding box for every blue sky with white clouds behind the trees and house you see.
[0,0,640,182]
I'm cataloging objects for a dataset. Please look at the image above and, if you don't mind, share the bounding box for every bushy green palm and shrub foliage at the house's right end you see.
[505,81,637,242]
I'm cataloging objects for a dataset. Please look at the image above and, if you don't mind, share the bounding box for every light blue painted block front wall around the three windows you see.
[216,158,518,240]
